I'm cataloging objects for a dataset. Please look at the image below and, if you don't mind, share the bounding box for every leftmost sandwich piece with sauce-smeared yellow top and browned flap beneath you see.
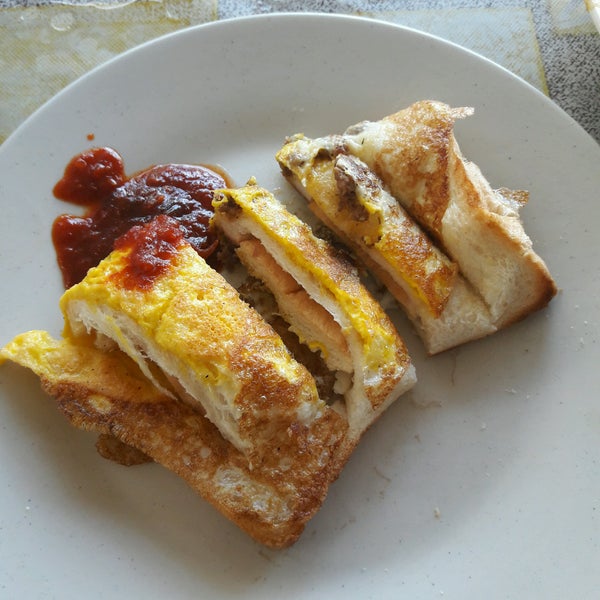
[1,217,348,547]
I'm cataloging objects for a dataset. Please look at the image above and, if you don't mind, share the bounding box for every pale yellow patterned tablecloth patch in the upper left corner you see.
[0,0,217,143]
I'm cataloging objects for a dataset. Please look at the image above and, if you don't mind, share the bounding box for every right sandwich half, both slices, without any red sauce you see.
[276,101,556,354]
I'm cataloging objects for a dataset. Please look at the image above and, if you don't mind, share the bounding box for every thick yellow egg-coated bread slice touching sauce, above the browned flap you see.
[60,221,340,466]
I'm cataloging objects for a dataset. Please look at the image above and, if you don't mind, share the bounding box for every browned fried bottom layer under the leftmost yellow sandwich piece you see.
[0,331,348,549]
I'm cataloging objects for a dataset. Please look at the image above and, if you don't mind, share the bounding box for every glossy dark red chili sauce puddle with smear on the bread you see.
[52,148,227,288]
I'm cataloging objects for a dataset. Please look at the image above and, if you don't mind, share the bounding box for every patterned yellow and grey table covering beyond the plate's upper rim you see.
[0,0,600,143]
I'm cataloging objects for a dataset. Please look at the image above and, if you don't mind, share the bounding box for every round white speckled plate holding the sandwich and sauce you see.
[0,15,600,600]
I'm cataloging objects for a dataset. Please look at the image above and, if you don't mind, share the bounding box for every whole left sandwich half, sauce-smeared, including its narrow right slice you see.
[0,197,415,548]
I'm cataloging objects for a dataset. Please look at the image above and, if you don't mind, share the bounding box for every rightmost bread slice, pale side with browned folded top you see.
[343,101,557,328]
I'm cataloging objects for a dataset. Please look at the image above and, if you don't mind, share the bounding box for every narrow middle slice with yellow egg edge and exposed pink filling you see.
[213,181,416,448]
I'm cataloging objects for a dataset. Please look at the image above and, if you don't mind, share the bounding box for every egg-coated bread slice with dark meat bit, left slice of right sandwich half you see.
[277,135,496,354]
